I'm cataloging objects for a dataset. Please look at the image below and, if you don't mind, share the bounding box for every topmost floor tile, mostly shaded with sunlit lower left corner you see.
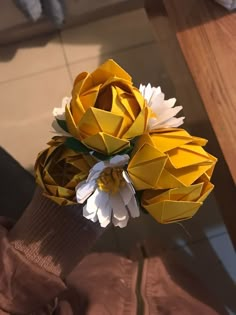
[62,9,154,63]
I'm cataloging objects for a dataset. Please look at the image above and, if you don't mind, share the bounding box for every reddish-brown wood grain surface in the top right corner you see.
[164,0,236,182]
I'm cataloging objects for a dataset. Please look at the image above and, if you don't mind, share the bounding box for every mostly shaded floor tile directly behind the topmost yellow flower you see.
[69,43,174,92]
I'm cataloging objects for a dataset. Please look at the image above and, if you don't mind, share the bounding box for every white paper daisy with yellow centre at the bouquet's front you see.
[76,154,140,228]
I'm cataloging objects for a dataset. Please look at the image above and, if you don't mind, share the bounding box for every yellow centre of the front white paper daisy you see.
[97,167,125,194]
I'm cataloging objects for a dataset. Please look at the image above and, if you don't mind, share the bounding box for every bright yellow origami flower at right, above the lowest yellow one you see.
[128,128,217,190]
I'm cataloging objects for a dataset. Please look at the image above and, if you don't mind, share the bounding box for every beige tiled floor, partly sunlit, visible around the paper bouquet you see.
[0,10,236,314]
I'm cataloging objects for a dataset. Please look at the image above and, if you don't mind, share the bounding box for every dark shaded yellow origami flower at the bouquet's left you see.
[35,137,96,206]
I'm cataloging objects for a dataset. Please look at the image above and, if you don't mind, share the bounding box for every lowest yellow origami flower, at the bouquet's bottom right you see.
[141,175,214,224]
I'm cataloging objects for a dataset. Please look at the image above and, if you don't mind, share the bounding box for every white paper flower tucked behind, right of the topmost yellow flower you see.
[139,83,185,130]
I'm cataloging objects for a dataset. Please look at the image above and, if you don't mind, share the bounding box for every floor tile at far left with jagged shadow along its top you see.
[0,35,65,82]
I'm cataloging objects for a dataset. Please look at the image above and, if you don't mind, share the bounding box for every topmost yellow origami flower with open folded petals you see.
[65,60,150,155]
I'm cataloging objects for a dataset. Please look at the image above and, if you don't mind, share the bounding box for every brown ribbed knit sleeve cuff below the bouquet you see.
[8,188,104,278]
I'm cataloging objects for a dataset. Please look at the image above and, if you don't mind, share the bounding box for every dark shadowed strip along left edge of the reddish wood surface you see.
[145,0,236,247]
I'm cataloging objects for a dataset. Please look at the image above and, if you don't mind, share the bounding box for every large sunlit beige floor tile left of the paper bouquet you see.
[0,67,71,168]
